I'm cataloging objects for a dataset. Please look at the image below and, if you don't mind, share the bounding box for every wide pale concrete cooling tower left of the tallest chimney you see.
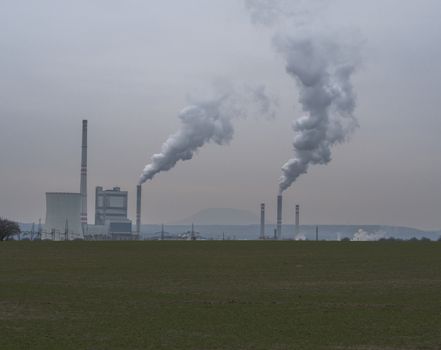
[44,192,82,239]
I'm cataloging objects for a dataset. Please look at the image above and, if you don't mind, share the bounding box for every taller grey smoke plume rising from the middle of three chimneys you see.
[246,0,359,193]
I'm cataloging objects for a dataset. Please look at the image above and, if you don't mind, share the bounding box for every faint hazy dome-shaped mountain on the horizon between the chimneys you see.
[171,208,259,225]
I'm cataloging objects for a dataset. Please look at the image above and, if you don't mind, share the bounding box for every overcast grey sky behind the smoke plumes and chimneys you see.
[0,0,441,229]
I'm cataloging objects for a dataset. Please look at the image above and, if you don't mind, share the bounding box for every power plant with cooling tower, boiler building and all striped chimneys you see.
[39,120,300,240]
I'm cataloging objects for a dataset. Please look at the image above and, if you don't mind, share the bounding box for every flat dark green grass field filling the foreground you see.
[0,241,441,350]
